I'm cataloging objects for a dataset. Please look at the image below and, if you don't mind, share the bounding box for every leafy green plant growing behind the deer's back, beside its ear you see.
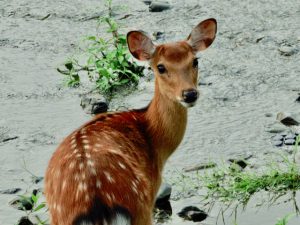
[58,0,144,94]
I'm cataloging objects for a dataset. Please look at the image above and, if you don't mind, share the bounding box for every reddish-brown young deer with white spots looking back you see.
[45,19,217,225]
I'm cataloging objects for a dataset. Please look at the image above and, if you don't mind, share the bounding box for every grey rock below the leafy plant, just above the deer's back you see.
[80,93,108,114]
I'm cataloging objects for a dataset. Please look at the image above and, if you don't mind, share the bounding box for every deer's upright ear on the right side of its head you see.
[187,18,217,52]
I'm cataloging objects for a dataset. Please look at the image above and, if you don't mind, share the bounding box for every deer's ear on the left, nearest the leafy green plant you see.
[127,31,155,61]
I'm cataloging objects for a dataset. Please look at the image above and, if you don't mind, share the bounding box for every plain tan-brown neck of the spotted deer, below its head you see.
[145,81,187,169]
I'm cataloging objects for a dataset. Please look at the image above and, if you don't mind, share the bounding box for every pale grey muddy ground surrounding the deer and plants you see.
[0,0,300,225]
